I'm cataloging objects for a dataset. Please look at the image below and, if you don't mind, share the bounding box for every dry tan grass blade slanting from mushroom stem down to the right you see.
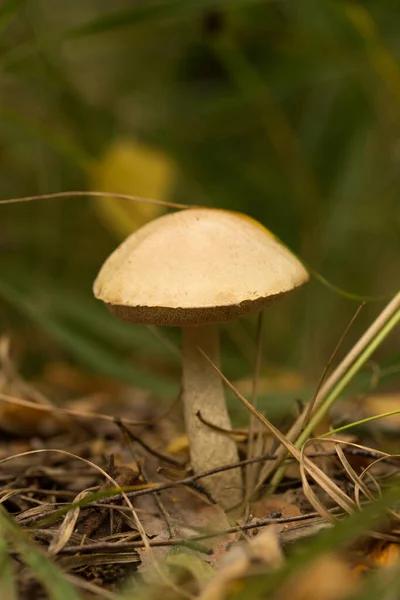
[199,348,357,516]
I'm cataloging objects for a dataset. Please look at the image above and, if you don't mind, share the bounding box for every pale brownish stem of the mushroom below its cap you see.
[182,325,242,508]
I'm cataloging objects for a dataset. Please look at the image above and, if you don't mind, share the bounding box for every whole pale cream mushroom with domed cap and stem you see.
[94,208,308,508]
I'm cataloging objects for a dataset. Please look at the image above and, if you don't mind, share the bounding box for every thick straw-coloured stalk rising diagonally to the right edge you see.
[256,292,400,491]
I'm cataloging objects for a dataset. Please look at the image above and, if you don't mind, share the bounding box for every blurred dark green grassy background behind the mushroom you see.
[0,0,400,408]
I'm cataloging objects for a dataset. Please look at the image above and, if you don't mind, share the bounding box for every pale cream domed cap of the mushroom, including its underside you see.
[93,208,308,326]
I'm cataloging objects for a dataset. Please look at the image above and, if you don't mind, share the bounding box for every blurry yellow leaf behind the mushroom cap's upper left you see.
[93,139,176,238]
